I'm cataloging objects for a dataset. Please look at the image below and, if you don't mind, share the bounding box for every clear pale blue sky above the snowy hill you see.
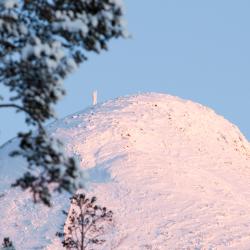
[0,0,250,144]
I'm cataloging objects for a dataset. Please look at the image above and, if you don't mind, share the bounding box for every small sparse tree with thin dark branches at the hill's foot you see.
[57,194,113,250]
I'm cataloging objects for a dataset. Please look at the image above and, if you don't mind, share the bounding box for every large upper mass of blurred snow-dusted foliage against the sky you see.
[0,0,124,124]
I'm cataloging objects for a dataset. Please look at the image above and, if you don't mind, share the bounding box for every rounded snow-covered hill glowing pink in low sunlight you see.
[0,93,250,250]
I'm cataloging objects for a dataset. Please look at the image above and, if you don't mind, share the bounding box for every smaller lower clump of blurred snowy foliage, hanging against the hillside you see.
[12,130,81,206]
